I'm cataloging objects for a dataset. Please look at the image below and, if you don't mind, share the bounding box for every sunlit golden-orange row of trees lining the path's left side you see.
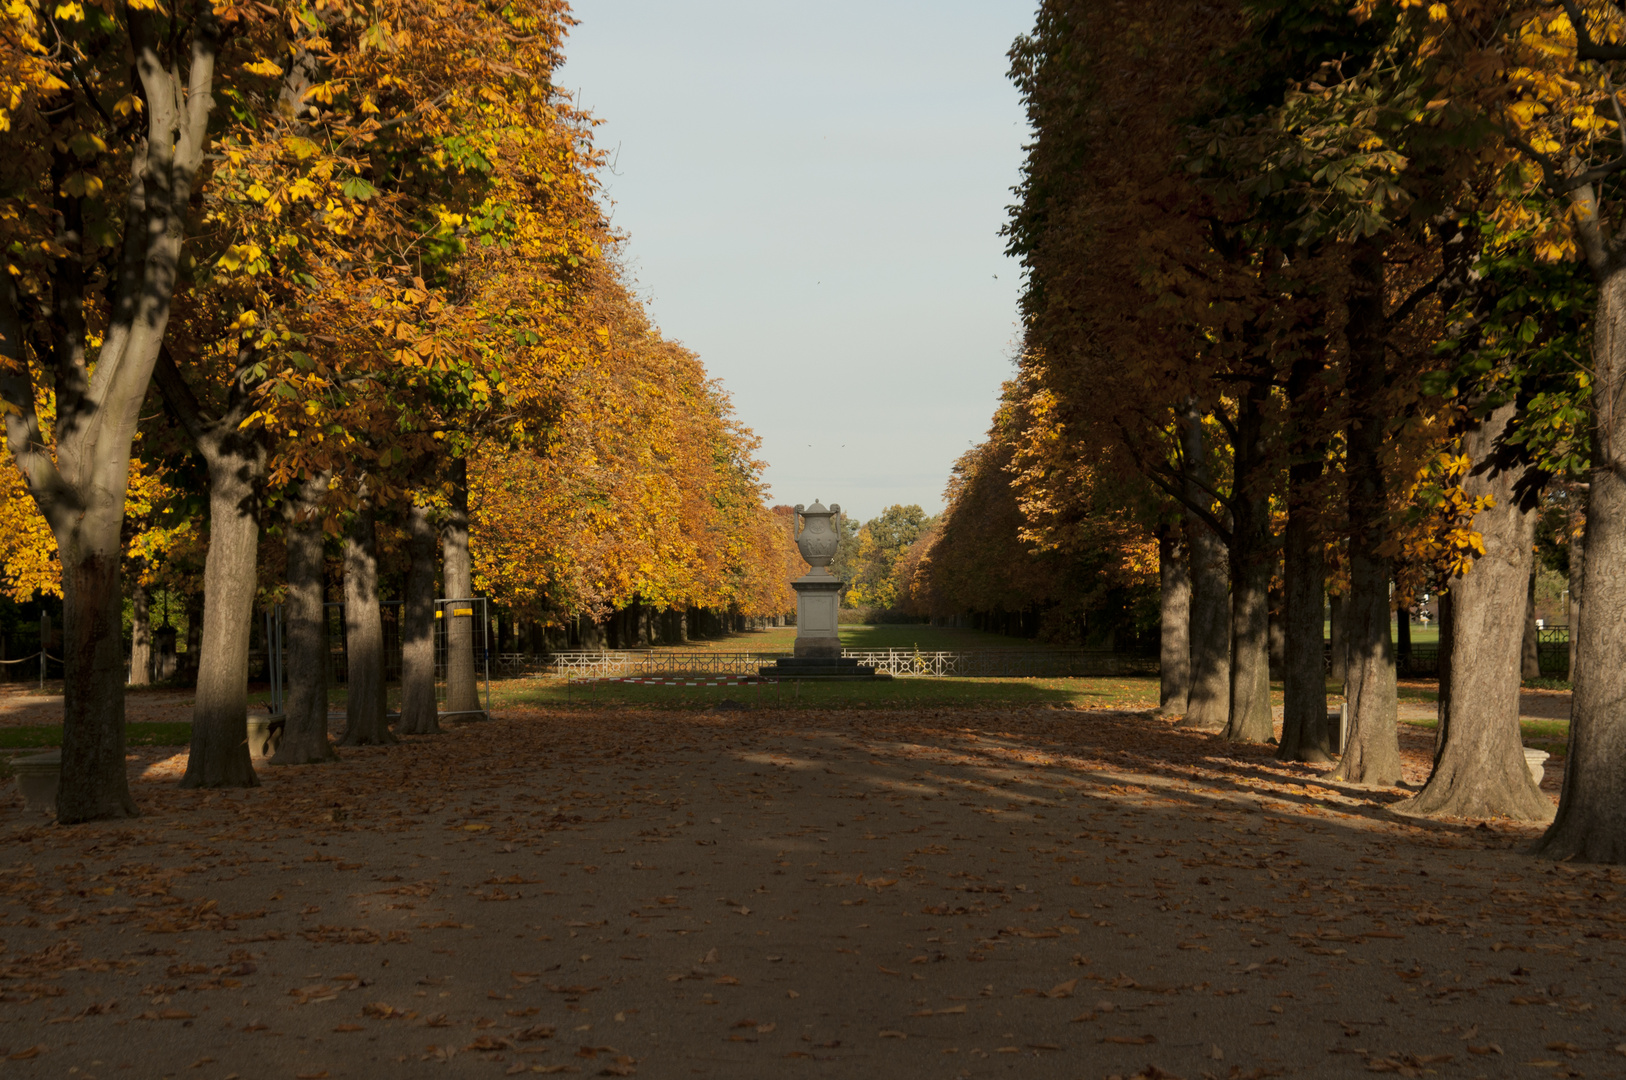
[0,0,789,821]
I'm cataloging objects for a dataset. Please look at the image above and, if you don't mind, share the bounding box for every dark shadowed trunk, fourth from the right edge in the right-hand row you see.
[1276,457,1341,761]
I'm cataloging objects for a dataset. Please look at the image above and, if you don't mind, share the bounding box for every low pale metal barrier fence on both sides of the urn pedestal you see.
[543,649,1158,678]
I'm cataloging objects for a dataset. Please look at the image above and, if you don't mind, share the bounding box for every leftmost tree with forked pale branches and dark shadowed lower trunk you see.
[0,0,239,823]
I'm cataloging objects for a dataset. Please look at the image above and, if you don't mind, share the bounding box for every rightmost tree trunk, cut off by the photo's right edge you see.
[1535,250,1626,862]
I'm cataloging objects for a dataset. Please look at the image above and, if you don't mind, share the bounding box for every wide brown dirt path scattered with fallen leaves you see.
[0,709,1626,1080]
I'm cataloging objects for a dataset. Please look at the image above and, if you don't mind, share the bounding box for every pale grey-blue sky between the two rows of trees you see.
[556,0,1036,520]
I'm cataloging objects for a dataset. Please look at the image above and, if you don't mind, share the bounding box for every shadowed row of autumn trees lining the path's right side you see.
[917,0,1626,862]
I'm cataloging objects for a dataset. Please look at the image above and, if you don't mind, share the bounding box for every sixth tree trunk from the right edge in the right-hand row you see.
[1180,413,1231,732]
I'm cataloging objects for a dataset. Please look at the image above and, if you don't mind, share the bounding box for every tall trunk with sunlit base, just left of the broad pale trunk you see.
[1333,244,1400,787]
